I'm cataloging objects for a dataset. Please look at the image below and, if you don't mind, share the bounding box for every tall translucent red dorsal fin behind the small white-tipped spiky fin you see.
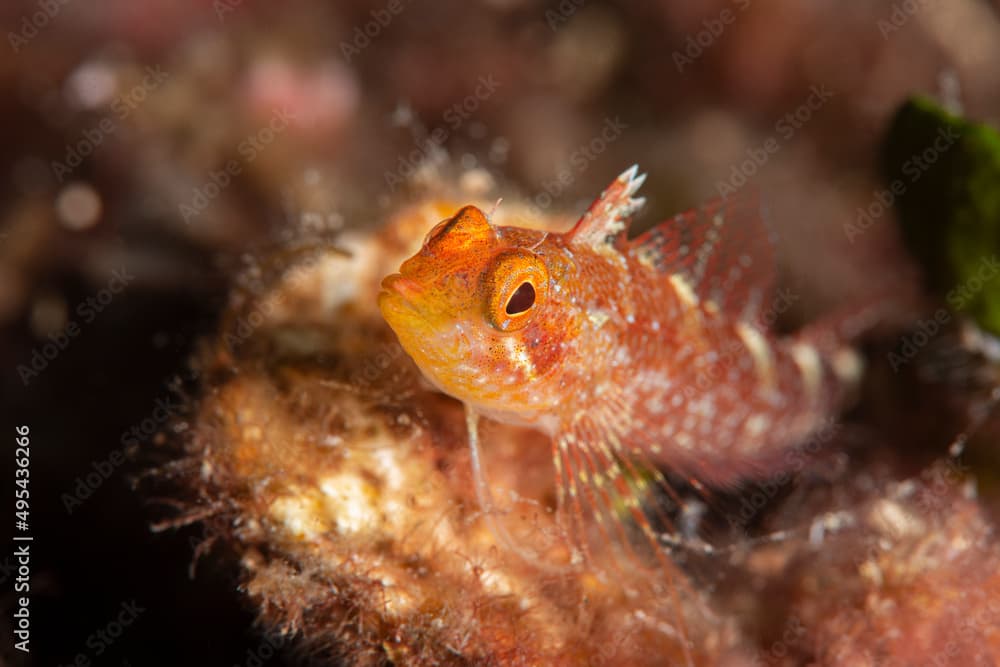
[629,191,775,327]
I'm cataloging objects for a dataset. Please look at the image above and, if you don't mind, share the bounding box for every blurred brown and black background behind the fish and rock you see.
[0,0,1000,666]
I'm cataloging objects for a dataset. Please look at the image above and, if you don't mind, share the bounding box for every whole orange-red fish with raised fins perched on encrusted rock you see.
[378,166,862,576]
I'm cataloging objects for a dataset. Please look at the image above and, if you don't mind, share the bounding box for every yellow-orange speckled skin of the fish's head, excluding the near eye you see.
[379,206,586,424]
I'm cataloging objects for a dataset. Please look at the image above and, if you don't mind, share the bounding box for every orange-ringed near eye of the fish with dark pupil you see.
[483,248,549,332]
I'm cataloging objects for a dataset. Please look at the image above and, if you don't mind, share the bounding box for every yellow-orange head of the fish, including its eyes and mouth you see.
[379,206,570,413]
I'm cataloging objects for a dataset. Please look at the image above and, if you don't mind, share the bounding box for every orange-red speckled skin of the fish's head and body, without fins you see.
[379,179,842,483]
